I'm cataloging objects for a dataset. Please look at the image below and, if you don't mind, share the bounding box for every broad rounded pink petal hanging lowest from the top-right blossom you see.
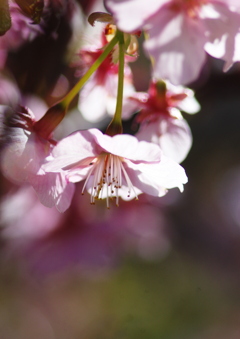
[145,8,206,85]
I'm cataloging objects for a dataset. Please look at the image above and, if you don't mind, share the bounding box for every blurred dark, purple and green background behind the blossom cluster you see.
[0,0,240,339]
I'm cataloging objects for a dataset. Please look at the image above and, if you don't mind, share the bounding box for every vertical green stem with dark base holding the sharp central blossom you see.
[106,31,125,135]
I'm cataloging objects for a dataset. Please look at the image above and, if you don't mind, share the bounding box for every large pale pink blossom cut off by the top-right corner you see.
[105,0,240,85]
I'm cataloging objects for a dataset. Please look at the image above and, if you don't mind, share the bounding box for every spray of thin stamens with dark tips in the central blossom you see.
[82,153,137,208]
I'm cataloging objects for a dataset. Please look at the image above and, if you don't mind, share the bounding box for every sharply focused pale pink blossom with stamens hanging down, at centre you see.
[44,129,187,207]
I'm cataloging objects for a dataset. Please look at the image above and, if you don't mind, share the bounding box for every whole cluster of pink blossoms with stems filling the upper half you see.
[0,0,240,212]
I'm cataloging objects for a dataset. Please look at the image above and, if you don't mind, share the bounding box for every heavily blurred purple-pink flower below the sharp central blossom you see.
[0,185,170,279]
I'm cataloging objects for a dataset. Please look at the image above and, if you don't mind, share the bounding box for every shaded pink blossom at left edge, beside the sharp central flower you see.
[1,107,74,212]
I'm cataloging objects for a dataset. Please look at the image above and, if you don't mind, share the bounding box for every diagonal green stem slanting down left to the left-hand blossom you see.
[61,35,118,108]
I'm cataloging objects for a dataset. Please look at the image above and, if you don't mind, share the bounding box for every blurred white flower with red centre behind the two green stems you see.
[76,18,136,122]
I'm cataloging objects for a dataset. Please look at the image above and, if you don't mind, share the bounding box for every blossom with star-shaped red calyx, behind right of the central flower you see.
[130,81,200,162]
